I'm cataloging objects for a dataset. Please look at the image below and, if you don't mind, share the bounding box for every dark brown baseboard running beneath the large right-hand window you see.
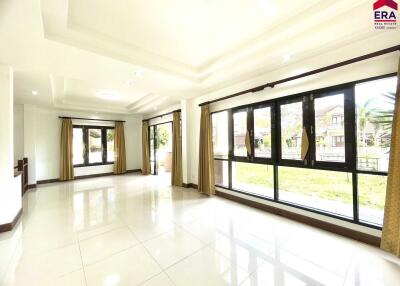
[216,191,381,247]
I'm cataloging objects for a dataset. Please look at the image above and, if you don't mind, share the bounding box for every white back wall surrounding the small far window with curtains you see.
[20,106,142,184]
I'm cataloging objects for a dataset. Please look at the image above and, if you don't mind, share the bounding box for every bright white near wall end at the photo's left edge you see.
[0,65,22,225]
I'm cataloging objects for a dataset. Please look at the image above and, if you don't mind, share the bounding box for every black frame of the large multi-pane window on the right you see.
[210,73,397,230]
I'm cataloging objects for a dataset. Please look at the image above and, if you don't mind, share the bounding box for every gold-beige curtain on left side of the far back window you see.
[60,119,74,181]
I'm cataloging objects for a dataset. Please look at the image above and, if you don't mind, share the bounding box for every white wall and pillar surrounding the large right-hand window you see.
[182,39,399,236]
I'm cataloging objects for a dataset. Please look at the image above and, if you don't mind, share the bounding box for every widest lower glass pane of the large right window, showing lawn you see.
[278,167,353,218]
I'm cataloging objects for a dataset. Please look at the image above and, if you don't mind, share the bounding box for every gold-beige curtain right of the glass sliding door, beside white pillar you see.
[171,111,182,187]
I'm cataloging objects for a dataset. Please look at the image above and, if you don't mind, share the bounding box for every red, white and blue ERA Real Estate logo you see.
[374,0,398,29]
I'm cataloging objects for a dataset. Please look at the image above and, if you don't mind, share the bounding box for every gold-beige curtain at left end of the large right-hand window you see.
[198,104,215,195]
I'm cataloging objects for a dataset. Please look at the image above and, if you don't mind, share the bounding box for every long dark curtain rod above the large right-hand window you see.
[199,45,400,106]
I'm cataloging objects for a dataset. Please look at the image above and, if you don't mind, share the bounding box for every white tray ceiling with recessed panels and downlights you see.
[0,0,400,114]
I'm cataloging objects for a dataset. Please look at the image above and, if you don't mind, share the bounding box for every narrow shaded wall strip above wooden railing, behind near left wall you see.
[14,104,24,166]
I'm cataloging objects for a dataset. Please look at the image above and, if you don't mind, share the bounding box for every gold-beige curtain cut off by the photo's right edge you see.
[381,58,400,257]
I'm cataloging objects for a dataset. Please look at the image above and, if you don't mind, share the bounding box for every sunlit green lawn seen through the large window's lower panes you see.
[236,164,386,210]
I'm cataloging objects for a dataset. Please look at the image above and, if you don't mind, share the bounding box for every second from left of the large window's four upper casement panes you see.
[254,107,271,158]
